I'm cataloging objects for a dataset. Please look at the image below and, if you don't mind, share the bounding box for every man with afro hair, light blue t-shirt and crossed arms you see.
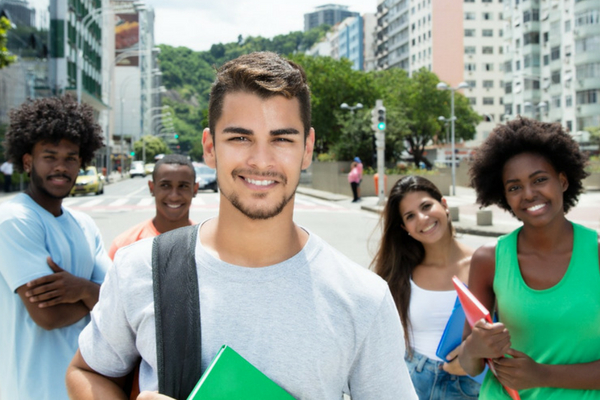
[0,97,111,400]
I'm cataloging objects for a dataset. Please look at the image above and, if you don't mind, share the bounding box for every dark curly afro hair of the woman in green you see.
[469,117,588,215]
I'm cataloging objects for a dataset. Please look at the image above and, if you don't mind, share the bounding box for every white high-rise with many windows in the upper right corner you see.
[503,0,600,133]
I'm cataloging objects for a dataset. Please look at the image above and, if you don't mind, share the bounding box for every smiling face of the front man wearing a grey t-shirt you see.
[202,92,315,219]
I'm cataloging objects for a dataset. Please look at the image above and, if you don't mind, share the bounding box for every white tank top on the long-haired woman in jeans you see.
[408,279,456,361]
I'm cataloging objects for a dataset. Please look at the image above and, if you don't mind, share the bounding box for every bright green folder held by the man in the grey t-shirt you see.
[187,345,294,400]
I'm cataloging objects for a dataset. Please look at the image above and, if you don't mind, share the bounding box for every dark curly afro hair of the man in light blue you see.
[4,95,103,172]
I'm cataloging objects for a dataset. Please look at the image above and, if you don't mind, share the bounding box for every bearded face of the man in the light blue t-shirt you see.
[23,139,81,199]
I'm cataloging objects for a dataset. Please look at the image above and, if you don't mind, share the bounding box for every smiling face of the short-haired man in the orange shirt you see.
[148,164,198,222]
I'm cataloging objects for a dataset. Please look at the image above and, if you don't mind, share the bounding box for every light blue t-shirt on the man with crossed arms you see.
[0,194,111,400]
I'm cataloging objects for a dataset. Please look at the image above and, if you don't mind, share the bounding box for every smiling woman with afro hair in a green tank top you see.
[459,117,600,400]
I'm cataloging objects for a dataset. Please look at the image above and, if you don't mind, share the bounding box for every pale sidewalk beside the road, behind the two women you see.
[297,186,600,236]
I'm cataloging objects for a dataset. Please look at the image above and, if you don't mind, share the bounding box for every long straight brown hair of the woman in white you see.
[371,175,452,355]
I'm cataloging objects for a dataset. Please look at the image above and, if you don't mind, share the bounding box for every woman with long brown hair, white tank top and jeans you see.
[371,176,480,400]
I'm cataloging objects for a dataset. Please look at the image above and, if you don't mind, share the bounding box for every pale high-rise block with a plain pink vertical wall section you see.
[375,0,506,147]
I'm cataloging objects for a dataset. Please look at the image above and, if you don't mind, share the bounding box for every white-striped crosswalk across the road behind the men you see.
[63,193,356,212]
